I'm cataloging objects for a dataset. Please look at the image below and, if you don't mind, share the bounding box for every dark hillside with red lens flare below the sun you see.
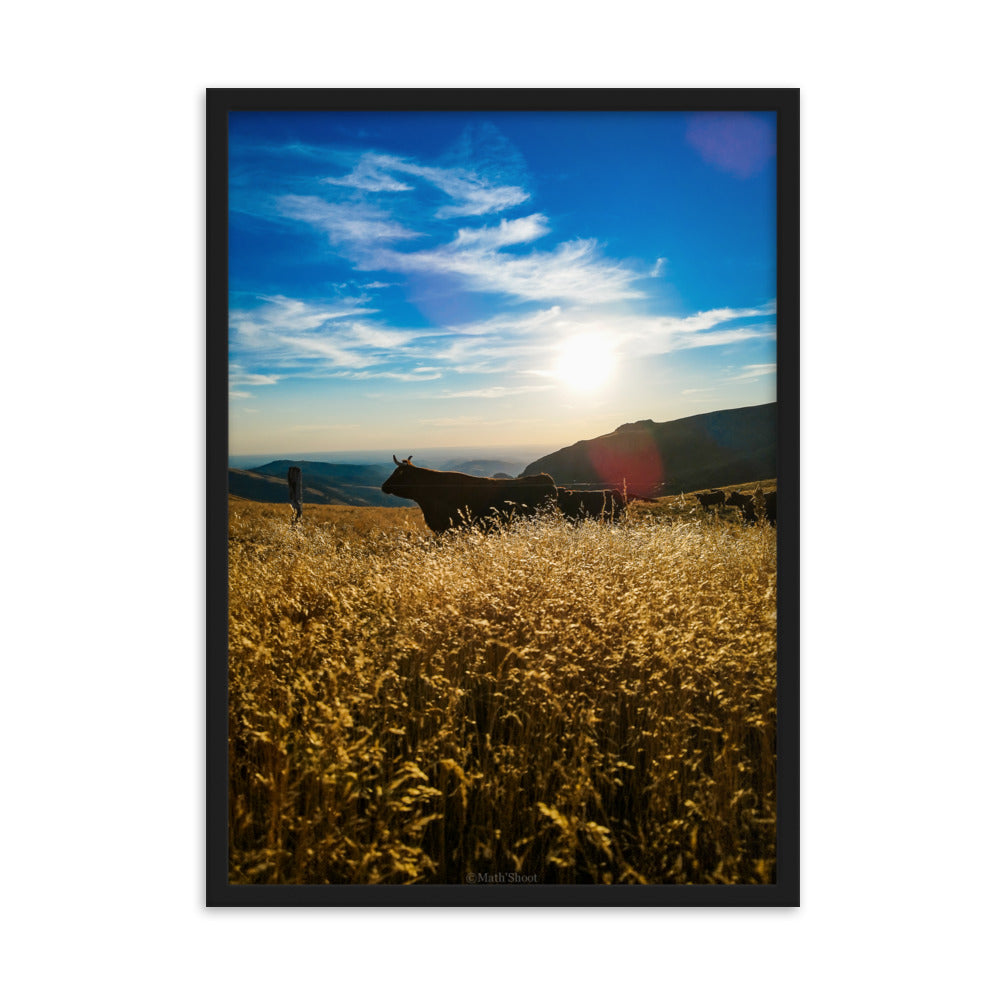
[523,403,778,496]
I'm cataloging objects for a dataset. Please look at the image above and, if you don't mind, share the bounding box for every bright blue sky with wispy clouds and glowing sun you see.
[229,112,776,457]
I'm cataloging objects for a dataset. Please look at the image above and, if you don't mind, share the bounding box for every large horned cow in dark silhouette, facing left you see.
[382,455,557,534]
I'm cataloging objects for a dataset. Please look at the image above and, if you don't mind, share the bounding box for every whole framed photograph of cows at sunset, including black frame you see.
[206,89,799,906]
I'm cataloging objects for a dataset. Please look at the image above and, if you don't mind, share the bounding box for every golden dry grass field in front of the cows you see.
[229,481,777,884]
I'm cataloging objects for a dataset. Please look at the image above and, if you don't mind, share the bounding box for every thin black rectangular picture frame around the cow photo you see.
[206,88,800,907]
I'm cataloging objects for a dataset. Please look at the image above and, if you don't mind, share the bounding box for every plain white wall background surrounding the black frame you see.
[0,0,998,998]
